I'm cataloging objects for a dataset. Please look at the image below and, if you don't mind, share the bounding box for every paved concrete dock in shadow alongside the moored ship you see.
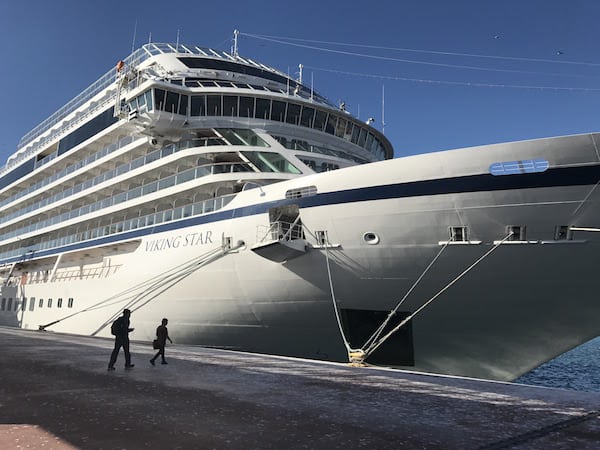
[0,327,600,450]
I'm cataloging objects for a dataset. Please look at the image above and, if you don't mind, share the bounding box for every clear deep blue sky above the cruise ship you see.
[0,0,600,163]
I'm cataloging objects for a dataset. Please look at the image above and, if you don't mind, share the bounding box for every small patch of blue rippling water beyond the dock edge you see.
[515,337,600,392]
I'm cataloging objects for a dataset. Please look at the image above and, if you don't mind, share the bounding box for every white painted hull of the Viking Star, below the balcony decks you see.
[2,131,600,380]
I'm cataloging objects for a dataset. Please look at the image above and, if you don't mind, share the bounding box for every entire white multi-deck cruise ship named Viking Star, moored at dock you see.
[0,39,600,380]
